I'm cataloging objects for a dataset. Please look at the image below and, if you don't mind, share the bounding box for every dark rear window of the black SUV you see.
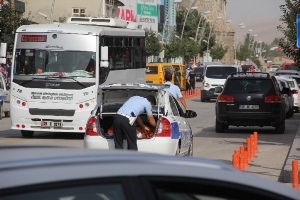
[224,79,275,93]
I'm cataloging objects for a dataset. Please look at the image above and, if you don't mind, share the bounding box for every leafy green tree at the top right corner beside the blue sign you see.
[277,0,300,65]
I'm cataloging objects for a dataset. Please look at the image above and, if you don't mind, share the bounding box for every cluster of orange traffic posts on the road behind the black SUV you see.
[232,131,258,171]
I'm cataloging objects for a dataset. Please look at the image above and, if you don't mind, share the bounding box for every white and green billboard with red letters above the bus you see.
[118,0,158,31]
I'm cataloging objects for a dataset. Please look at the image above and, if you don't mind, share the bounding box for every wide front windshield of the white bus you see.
[13,49,96,78]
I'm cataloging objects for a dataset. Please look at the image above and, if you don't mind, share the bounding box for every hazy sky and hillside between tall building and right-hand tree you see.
[226,0,285,44]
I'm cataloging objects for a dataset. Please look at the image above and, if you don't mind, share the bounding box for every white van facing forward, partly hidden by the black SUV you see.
[201,65,242,102]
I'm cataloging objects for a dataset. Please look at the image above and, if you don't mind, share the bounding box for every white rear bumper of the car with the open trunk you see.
[83,135,178,155]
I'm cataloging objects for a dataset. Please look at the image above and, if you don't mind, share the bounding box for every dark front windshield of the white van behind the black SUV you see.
[205,66,237,79]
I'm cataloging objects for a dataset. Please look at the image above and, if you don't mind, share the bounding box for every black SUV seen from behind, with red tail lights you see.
[215,72,289,134]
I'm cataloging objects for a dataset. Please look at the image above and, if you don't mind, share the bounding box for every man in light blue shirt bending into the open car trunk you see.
[113,95,156,150]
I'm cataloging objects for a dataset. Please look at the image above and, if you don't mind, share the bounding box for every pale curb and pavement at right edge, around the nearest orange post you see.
[283,121,300,183]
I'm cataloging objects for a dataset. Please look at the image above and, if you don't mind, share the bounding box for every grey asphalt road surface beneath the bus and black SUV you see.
[0,83,300,182]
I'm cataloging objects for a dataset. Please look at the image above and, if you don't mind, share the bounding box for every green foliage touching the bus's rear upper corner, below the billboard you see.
[146,30,163,56]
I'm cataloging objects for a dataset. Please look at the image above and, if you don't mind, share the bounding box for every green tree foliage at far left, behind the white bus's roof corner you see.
[0,4,31,53]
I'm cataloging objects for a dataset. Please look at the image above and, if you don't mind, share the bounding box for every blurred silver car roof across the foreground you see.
[0,146,299,198]
